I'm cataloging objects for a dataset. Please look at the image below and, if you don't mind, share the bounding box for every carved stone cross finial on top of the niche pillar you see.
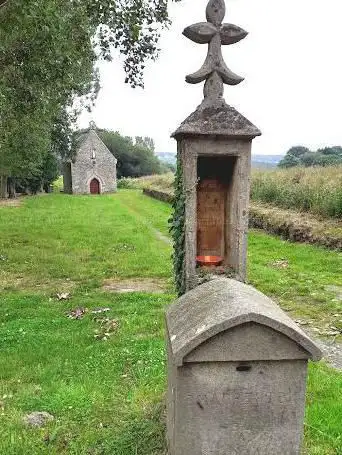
[183,0,248,101]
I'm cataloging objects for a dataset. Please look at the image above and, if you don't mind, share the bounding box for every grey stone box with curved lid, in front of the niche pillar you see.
[166,278,321,455]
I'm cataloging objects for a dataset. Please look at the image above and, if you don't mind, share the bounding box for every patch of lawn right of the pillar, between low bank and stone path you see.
[248,231,342,330]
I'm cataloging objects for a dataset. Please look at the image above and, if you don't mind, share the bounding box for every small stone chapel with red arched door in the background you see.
[63,122,117,194]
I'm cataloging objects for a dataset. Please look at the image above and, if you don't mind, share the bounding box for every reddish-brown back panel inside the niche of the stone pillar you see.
[197,178,227,257]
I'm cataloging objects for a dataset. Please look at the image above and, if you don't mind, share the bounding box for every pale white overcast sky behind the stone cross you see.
[79,0,342,155]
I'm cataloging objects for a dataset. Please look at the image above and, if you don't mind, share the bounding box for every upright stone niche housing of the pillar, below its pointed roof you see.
[174,134,251,290]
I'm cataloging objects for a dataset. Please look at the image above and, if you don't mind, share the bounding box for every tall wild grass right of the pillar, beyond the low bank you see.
[251,166,342,218]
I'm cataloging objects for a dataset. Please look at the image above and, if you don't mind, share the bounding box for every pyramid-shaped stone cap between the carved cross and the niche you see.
[172,99,261,139]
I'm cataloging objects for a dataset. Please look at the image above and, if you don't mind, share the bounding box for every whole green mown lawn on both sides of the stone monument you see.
[0,190,342,455]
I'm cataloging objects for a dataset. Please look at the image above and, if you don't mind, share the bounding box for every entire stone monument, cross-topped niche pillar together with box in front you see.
[166,0,321,455]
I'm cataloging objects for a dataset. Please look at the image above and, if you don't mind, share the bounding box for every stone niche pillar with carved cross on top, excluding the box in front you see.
[173,0,261,294]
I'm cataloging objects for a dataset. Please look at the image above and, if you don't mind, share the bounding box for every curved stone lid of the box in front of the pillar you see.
[166,278,322,366]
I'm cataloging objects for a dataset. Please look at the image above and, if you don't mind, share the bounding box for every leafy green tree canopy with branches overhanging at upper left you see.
[0,0,179,196]
